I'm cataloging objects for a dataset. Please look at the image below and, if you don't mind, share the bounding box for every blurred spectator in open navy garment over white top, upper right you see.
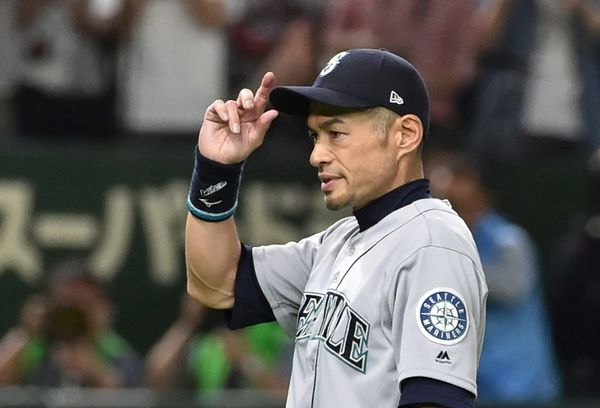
[471,0,600,158]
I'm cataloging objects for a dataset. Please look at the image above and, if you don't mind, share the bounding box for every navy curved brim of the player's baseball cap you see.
[269,86,372,116]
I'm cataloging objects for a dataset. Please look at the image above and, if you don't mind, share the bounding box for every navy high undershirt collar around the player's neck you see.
[353,179,431,232]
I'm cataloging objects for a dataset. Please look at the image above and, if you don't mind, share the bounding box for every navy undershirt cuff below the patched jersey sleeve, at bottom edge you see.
[398,377,475,408]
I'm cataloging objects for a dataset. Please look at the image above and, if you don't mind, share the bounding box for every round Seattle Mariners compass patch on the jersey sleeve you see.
[417,288,469,345]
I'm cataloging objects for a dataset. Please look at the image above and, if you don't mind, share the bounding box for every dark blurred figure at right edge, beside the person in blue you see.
[548,148,600,398]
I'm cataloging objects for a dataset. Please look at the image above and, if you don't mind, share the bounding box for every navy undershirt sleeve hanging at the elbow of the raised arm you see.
[225,244,275,330]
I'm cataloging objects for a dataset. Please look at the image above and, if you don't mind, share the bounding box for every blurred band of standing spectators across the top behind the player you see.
[0,0,600,154]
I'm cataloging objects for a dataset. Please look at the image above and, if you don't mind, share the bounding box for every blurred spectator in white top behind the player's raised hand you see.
[119,0,244,137]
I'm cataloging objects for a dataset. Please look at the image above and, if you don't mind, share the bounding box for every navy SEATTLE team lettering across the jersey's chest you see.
[296,290,370,373]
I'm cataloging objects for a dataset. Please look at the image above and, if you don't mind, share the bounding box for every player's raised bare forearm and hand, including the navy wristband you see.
[185,72,277,309]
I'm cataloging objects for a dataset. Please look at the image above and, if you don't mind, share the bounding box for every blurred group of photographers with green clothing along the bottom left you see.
[0,259,291,397]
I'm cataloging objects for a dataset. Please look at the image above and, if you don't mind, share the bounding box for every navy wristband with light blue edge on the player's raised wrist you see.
[187,147,244,222]
